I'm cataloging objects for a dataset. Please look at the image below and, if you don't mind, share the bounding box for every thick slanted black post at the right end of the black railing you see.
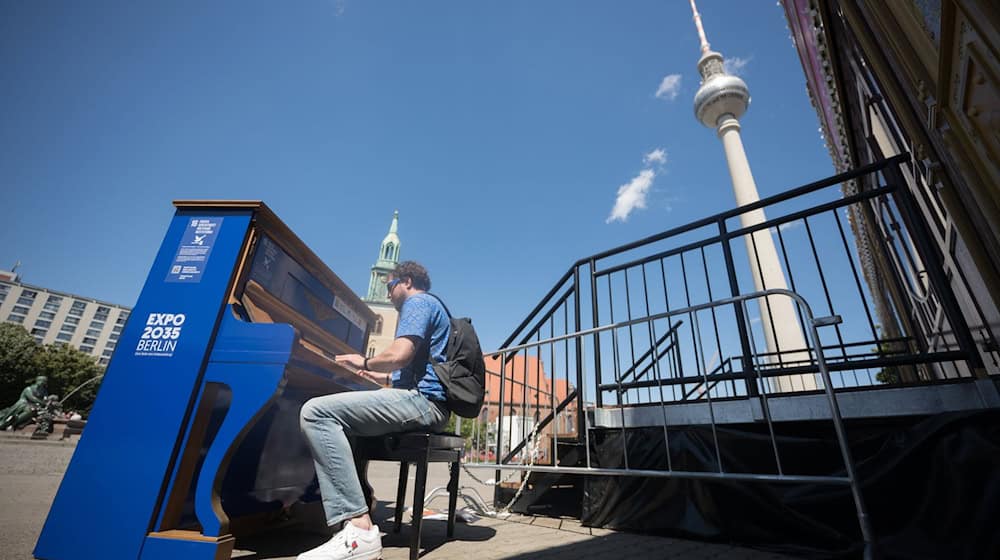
[883,161,987,379]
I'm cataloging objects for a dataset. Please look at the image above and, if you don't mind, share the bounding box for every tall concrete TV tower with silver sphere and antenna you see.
[691,0,817,391]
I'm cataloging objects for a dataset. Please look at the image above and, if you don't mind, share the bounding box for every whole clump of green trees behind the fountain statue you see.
[0,323,102,415]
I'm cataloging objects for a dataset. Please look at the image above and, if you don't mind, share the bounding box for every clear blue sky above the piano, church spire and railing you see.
[0,0,833,348]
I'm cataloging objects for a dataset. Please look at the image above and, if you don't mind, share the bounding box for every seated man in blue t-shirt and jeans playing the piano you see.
[298,261,451,560]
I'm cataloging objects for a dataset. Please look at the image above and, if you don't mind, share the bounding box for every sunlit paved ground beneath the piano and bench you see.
[0,433,789,560]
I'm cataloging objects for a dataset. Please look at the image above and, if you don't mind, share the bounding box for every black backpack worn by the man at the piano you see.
[428,293,486,418]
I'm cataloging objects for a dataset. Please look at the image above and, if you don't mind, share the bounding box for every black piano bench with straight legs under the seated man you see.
[355,432,465,560]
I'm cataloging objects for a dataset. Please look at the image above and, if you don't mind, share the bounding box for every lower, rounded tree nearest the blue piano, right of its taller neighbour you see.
[34,344,103,415]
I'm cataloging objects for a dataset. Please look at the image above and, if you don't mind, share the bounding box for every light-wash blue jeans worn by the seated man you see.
[299,389,450,526]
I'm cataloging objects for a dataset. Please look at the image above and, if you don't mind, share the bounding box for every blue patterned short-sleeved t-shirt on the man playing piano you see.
[392,292,451,401]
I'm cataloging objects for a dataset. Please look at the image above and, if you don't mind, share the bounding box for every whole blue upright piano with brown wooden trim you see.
[34,201,377,560]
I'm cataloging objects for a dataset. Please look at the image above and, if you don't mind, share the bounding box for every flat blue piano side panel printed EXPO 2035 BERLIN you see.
[35,209,252,560]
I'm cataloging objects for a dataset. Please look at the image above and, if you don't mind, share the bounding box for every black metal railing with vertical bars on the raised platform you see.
[494,156,984,416]
